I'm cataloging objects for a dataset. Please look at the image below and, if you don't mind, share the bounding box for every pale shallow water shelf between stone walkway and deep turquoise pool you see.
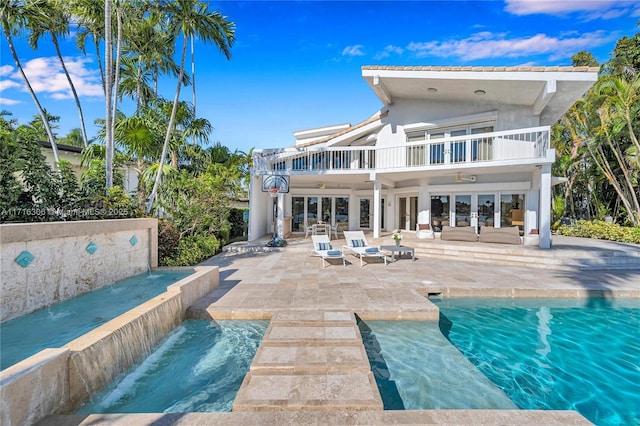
[359,321,517,410]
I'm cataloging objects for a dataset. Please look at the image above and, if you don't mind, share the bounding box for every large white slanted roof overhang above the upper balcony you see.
[362,66,598,125]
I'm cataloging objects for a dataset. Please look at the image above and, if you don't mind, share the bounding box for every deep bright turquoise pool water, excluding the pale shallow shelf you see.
[436,299,640,425]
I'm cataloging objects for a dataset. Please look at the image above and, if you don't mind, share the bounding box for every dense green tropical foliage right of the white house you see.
[553,26,640,227]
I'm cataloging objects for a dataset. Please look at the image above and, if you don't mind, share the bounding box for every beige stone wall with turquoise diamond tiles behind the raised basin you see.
[0,219,158,322]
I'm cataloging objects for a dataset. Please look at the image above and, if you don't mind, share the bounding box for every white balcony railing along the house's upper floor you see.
[253,126,549,174]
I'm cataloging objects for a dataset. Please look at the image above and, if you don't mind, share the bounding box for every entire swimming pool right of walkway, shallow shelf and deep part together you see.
[366,299,640,425]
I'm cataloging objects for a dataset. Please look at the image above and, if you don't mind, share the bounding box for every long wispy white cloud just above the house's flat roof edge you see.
[407,31,617,60]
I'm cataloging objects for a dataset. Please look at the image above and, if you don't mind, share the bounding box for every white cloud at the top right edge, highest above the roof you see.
[505,0,638,20]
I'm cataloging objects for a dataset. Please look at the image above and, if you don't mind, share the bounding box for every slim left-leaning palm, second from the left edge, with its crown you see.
[29,0,88,147]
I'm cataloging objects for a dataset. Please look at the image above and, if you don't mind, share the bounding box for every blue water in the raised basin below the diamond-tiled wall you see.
[0,270,193,370]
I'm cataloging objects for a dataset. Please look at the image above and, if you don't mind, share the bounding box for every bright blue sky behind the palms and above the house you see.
[0,0,640,152]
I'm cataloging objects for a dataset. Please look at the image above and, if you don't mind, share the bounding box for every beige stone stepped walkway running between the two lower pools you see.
[233,311,383,411]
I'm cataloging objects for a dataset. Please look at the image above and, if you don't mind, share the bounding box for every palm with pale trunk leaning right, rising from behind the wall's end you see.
[147,0,235,211]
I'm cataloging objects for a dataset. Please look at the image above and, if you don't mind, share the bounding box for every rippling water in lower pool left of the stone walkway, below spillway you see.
[78,320,269,414]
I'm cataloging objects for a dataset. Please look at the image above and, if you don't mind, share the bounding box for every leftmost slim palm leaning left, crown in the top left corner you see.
[0,0,60,168]
